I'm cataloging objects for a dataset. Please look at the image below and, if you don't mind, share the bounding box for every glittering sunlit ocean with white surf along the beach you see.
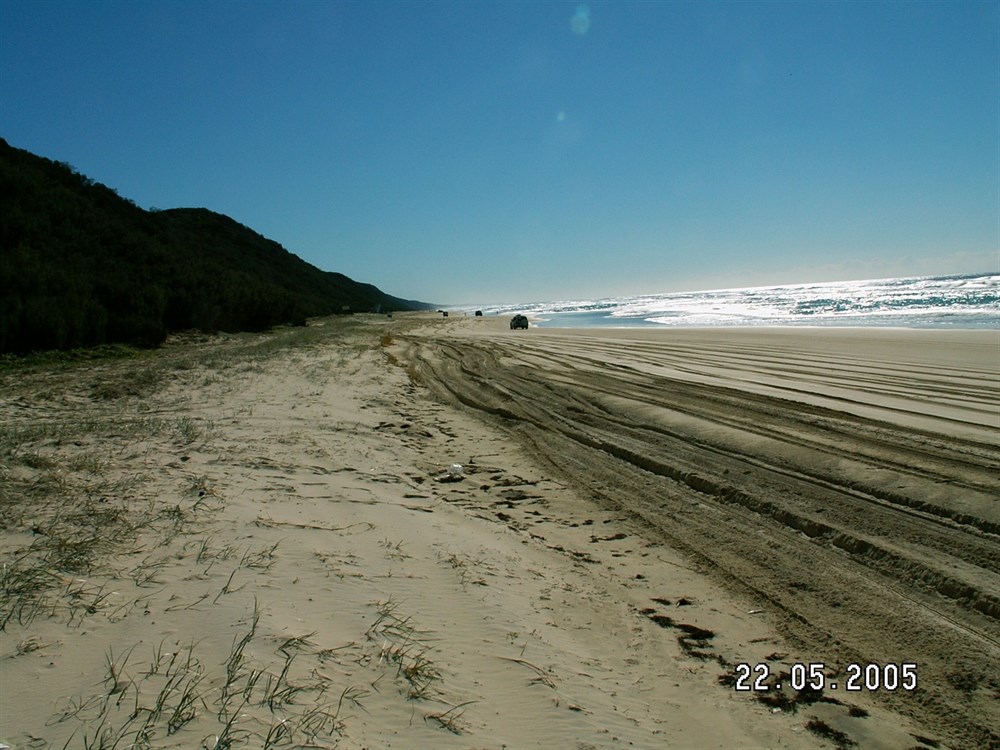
[470,274,1000,330]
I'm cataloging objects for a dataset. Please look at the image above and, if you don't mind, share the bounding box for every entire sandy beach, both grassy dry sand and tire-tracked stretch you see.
[0,315,1000,750]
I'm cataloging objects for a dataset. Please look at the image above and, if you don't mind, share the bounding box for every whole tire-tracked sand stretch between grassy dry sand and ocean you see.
[403,321,1000,747]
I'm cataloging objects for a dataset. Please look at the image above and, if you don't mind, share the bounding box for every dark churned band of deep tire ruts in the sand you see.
[401,336,1000,747]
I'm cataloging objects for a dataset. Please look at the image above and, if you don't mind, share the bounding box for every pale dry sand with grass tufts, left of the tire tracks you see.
[9,316,908,750]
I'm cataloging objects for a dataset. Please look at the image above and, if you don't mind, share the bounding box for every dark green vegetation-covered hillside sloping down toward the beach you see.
[0,139,427,352]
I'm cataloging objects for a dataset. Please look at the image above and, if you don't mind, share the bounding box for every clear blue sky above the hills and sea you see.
[0,0,1000,303]
